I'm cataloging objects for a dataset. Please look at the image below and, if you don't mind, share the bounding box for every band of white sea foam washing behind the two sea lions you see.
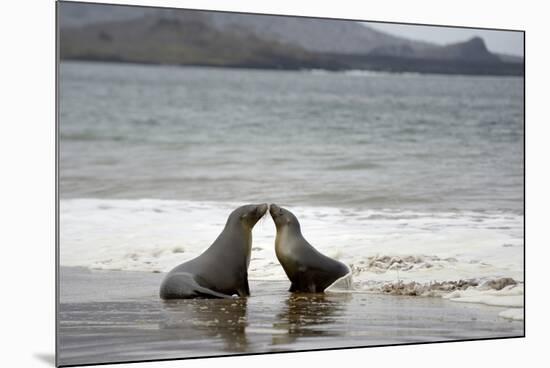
[60,199,523,307]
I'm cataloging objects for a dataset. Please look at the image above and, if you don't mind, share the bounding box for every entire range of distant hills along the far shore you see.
[59,3,523,75]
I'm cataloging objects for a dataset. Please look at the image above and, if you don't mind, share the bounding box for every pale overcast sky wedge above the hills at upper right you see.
[365,22,523,56]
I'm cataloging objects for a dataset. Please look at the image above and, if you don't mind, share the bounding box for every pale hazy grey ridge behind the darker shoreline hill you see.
[60,3,431,54]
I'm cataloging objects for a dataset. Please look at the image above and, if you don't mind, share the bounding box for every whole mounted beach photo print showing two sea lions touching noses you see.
[57,2,524,366]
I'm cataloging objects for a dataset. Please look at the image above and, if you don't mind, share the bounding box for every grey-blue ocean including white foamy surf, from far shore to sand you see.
[59,62,524,318]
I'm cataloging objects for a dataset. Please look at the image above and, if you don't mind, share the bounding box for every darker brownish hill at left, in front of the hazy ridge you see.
[60,14,328,69]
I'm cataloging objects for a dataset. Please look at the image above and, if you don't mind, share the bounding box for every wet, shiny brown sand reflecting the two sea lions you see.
[58,267,524,365]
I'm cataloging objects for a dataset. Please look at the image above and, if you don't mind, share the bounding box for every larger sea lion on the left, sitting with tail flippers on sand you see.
[160,204,268,299]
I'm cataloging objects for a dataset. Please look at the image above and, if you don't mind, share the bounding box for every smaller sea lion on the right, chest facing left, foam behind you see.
[269,204,350,293]
